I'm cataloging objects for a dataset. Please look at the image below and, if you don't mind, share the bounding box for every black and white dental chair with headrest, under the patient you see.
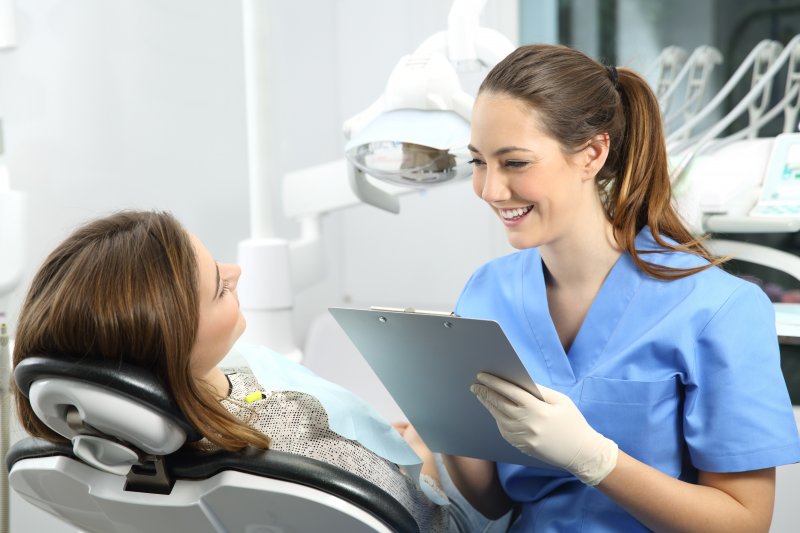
[6,356,419,533]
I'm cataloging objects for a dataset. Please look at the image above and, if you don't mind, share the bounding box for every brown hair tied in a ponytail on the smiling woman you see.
[478,44,723,280]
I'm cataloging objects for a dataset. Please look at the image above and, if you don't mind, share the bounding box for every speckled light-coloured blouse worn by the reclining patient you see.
[212,372,448,533]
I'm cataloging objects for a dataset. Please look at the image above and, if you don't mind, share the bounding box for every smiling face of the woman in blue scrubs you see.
[470,93,596,249]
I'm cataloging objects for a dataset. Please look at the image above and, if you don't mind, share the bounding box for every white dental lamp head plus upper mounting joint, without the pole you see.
[344,1,514,213]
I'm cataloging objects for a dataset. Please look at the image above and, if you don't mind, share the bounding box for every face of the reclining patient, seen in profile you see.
[190,235,245,378]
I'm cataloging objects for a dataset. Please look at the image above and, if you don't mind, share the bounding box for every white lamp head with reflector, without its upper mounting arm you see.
[344,52,474,213]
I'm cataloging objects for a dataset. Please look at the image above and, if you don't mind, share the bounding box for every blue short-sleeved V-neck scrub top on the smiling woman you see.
[456,227,800,532]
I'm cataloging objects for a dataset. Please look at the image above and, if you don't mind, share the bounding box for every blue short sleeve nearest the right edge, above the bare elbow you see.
[684,282,800,472]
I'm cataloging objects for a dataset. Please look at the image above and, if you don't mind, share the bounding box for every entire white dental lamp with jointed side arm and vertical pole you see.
[234,0,514,364]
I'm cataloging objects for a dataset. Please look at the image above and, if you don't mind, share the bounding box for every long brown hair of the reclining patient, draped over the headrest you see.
[14,211,269,450]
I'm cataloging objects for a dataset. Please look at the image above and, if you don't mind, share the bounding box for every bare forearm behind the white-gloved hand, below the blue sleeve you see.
[597,451,775,533]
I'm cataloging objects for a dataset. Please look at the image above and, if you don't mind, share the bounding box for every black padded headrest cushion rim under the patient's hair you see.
[14,355,202,442]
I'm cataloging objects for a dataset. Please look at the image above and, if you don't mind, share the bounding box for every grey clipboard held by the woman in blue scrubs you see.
[328,307,553,469]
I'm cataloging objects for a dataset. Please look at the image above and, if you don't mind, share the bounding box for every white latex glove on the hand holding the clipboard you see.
[470,372,618,486]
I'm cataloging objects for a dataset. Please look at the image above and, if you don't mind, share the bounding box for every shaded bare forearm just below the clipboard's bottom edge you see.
[442,455,512,519]
